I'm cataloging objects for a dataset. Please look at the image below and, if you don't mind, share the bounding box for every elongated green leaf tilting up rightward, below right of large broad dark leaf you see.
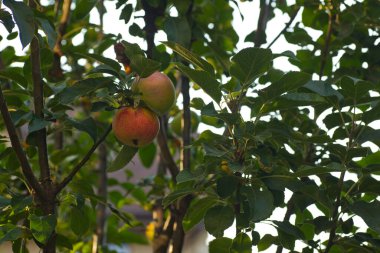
[259,72,311,101]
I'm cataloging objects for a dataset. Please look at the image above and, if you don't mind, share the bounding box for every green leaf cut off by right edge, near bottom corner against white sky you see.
[350,200,380,233]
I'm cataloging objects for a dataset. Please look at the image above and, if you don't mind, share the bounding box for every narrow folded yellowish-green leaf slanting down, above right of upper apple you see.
[163,41,214,76]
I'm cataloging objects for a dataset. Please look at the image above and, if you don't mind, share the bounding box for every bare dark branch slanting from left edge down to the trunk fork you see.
[0,87,45,199]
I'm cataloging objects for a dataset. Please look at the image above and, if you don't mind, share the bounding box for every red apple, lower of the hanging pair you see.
[112,106,160,147]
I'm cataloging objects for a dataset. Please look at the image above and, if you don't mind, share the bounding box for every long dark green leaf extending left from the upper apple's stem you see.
[51,77,113,105]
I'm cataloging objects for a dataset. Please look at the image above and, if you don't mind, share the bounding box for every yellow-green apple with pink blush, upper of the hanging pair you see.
[132,71,176,115]
